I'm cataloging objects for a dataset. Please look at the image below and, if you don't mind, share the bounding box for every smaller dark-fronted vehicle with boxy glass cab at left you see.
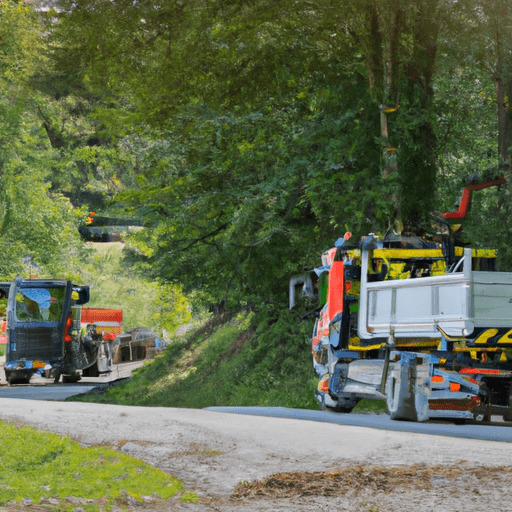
[0,277,112,384]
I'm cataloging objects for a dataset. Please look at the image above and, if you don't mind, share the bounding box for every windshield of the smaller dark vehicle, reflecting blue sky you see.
[16,288,65,322]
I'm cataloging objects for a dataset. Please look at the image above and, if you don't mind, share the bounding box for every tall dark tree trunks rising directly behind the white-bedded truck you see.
[366,0,440,232]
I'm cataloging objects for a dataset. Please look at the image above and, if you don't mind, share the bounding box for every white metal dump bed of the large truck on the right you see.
[358,251,512,338]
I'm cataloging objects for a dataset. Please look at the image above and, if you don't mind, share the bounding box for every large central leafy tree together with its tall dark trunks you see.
[48,0,512,301]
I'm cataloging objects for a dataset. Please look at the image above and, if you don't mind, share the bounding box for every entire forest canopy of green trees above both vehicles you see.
[0,0,512,305]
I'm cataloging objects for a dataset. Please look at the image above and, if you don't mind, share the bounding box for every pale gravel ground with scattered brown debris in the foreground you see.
[0,399,512,512]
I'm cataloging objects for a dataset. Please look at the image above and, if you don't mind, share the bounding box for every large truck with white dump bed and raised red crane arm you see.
[290,174,512,423]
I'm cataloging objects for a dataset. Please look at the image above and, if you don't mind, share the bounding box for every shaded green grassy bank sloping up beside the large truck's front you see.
[72,308,317,408]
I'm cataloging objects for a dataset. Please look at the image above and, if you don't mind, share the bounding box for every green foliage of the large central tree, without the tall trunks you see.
[51,1,396,305]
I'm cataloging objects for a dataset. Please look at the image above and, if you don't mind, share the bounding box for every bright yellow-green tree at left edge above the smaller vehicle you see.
[0,2,84,279]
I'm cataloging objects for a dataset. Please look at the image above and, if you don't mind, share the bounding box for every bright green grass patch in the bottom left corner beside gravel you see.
[0,422,194,511]
